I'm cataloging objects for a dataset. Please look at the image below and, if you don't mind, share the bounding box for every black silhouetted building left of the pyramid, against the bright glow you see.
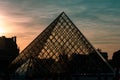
[0,36,19,74]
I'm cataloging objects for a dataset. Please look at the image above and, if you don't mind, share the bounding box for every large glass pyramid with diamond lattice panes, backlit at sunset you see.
[9,12,112,76]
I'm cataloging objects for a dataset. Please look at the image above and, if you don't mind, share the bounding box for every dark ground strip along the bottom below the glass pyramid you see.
[0,74,119,80]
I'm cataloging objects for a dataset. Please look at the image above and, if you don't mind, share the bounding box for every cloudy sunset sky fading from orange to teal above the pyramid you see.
[0,0,120,58]
